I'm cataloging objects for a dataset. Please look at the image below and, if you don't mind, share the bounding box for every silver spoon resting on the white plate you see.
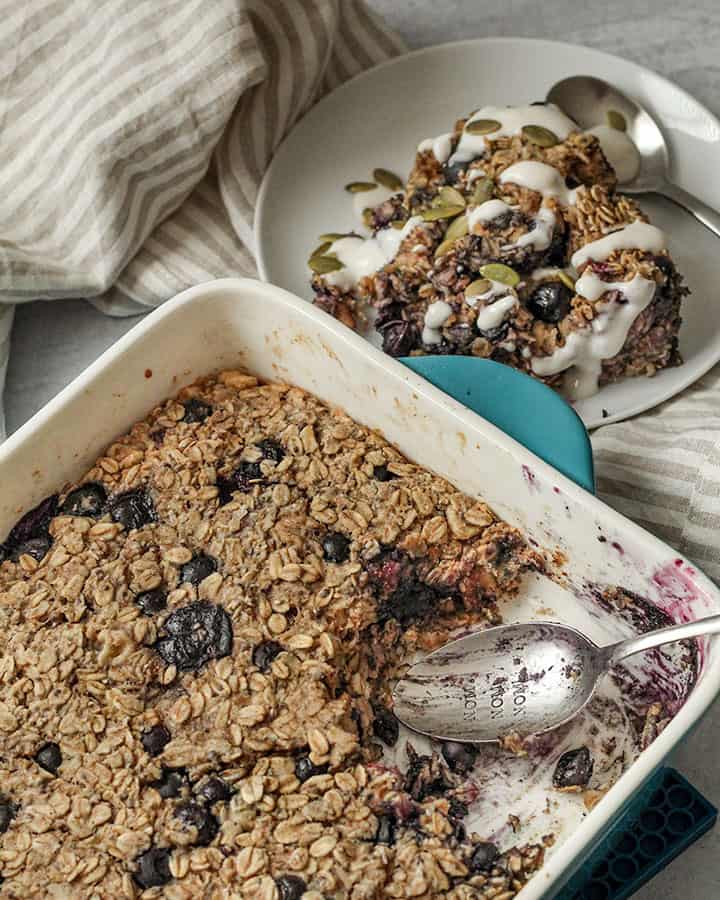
[547,75,720,237]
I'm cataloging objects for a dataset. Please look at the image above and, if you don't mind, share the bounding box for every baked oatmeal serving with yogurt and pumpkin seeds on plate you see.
[309,104,688,399]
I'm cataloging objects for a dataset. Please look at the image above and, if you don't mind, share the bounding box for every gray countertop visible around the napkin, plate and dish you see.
[5,0,720,900]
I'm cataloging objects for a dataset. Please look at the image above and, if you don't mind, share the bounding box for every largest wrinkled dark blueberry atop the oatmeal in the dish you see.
[155,601,233,671]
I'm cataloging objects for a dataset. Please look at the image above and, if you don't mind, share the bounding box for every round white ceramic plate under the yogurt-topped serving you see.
[255,38,720,428]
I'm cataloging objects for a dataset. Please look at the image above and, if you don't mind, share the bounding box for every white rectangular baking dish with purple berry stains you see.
[0,279,720,900]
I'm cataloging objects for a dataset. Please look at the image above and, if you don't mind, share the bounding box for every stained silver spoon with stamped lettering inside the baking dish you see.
[393,615,720,743]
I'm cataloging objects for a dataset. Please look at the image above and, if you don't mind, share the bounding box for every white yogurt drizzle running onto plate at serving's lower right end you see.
[532,274,655,400]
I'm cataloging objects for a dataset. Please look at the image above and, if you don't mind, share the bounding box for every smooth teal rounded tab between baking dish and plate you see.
[400,356,595,492]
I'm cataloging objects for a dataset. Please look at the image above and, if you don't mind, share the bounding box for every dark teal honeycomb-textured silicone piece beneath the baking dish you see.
[555,767,717,900]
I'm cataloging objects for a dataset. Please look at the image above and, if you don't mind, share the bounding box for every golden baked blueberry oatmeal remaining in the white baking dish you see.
[0,371,556,900]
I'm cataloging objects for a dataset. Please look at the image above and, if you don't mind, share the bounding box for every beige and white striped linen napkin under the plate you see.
[0,0,720,580]
